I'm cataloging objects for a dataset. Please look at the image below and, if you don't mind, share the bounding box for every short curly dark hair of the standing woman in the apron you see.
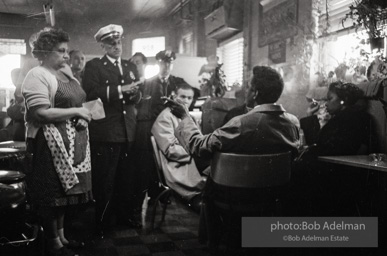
[32,28,70,60]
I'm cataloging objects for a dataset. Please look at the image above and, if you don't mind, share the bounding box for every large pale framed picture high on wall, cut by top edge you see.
[258,0,298,47]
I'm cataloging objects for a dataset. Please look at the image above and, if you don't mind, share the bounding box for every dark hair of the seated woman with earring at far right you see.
[328,81,364,106]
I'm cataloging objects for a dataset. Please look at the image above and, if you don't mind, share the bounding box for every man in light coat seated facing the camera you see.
[152,83,205,210]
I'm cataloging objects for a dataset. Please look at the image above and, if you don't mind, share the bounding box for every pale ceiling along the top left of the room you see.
[0,0,185,23]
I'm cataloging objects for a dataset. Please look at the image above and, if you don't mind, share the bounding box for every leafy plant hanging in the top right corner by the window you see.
[343,0,387,48]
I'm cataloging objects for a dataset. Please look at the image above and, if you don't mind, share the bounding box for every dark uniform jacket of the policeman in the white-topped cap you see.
[83,56,141,142]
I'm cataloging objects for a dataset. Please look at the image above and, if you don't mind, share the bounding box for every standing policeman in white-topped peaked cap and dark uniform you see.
[83,24,141,235]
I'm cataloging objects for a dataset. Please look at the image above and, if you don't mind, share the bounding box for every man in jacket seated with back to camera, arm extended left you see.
[170,66,300,156]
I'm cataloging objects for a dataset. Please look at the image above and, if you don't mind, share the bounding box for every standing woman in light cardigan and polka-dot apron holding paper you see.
[22,28,92,255]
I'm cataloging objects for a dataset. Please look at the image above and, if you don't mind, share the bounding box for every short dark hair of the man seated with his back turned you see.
[251,66,284,103]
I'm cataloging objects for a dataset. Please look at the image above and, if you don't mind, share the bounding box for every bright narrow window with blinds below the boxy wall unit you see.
[216,37,243,86]
